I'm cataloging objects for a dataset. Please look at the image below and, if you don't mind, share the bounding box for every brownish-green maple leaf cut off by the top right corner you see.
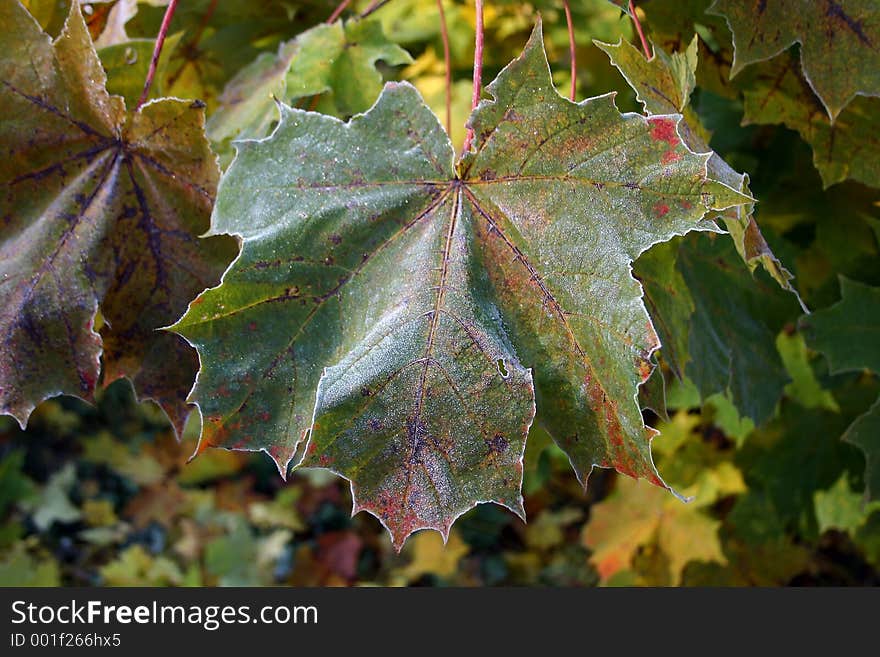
[709,0,880,121]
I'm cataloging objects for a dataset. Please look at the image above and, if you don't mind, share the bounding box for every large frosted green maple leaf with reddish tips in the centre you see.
[173,27,751,546]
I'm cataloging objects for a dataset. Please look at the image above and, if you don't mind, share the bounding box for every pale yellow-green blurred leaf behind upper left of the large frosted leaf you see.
[208,20,412,152]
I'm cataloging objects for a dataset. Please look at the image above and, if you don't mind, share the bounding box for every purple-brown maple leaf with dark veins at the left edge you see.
[0,1,234,432]
